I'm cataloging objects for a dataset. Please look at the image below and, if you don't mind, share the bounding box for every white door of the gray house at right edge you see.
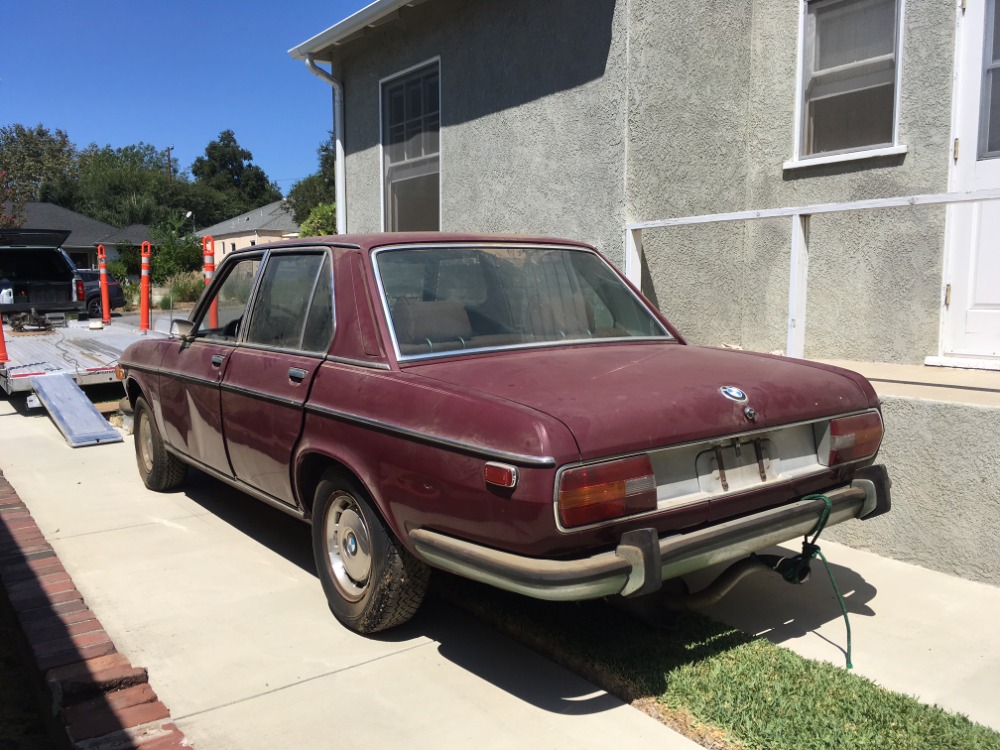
[942,0,1000,359]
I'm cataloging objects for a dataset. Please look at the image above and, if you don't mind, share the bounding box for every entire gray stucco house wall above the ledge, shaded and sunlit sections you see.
[335,0,954,363]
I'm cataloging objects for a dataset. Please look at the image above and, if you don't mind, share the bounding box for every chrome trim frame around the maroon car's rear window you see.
[371,240,677,363]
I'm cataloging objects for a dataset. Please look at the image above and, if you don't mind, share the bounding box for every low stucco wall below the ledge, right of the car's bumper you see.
[824,397,1000,585]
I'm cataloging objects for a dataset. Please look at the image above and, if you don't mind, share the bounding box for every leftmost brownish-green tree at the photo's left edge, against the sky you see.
[0,124,76,203]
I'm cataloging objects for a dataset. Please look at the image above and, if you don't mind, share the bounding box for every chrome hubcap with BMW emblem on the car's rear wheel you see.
[324,492,372,601]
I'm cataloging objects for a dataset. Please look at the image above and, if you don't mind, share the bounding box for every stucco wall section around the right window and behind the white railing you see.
[627,0,954,363]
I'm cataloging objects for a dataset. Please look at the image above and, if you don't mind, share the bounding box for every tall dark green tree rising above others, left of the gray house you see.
[191,130,281,214]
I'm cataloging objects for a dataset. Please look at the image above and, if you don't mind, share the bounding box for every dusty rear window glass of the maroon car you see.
[376,246,670,358]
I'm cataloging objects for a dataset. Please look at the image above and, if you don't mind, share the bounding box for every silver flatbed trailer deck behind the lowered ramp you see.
[0,321,164,395]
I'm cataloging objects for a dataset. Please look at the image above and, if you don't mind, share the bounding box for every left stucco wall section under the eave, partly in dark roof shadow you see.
[336,0,627,262]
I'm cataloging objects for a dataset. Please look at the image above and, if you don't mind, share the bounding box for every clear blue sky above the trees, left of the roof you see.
[0,0,370,194]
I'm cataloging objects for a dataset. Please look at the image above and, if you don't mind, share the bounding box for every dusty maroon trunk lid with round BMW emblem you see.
[407,343,872,460]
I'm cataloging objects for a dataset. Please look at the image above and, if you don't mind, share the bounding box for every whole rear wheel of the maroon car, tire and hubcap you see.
[312,474,430,633]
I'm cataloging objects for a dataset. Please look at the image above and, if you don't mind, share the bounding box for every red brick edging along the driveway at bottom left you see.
[0,471,191,750]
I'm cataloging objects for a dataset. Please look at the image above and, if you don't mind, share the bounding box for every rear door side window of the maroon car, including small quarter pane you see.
[246,253,326,349]
